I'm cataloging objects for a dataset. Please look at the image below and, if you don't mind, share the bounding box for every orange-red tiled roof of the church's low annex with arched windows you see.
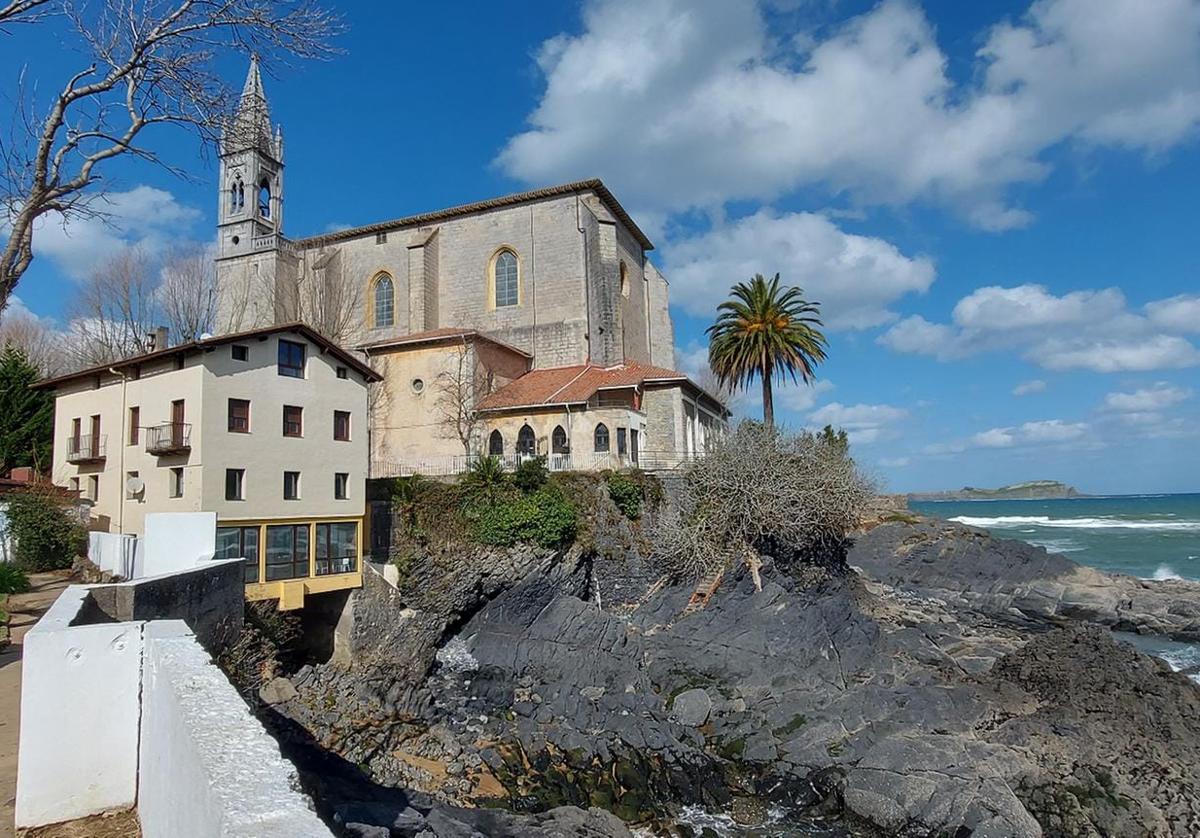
[479,361,719,411]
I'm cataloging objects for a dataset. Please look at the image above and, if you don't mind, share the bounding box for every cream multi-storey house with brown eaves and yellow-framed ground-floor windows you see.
[37,324,378,607]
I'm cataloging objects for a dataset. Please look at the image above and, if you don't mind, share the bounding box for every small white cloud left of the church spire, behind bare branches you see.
[27,186,202,280]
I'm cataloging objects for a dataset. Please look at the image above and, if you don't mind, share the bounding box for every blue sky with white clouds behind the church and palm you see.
[0,0,1200,492]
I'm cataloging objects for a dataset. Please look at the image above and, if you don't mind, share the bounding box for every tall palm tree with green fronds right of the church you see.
[706,274,828,427]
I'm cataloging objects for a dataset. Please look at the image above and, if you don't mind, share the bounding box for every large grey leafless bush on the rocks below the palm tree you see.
[652,421,874,577]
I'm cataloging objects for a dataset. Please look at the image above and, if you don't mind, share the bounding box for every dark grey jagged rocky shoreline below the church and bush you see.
[234,509,1200,838]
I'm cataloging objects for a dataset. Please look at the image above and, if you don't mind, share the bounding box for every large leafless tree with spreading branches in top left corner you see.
[0,0,342,310]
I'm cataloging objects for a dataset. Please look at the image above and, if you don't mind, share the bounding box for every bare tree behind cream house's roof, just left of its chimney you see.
[67,247,158,366]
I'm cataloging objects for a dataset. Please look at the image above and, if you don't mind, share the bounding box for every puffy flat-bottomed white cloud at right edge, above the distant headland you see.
[878,285,1200,372]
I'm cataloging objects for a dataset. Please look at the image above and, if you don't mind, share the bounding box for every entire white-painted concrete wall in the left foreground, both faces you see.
[16,562,331,838]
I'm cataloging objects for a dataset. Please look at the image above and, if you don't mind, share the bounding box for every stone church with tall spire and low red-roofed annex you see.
[216,61,728,477]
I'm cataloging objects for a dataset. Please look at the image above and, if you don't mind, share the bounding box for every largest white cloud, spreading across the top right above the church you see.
[498,0,1200,229]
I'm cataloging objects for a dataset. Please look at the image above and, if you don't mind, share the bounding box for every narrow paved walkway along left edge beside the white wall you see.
[0,570,71,838]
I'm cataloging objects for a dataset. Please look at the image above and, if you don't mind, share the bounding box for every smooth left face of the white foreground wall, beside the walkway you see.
[17,585,142,827]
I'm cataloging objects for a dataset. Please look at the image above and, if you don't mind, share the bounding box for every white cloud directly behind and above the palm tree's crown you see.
[666,210,934,329]
